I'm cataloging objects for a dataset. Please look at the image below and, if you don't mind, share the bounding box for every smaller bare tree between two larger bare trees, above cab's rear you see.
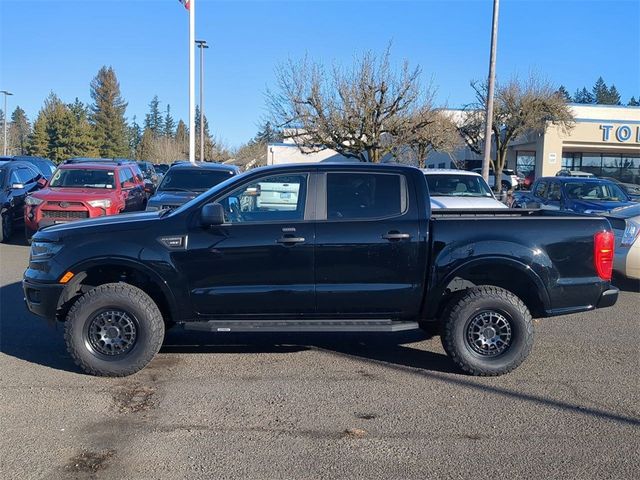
[396,108,463,168]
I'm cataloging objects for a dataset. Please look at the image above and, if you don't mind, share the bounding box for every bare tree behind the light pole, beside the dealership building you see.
[459,75,574,189]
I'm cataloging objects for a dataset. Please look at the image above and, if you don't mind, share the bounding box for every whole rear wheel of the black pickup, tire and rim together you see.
[442,286,534,376]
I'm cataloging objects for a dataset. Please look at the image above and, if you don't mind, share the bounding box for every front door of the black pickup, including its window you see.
[174,171,315,319]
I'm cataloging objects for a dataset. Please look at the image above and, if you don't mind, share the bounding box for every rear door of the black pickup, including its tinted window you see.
[315,171,424,318]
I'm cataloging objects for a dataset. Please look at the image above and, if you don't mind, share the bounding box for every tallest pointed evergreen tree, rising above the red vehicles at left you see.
[91,66,129,158]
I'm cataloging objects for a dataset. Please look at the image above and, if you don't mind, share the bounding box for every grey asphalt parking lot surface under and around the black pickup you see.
[0,238,640,479]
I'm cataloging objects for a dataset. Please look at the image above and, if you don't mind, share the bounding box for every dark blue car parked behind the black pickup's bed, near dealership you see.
[512,177,632,213]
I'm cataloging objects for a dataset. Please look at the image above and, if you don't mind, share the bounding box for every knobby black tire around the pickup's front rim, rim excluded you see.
[64,283,164,377]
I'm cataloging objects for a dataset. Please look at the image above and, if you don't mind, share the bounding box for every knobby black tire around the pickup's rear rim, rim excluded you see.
[441,286,534,376]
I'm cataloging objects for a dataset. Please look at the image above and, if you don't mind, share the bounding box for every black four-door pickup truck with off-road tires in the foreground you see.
[24,164,618,376]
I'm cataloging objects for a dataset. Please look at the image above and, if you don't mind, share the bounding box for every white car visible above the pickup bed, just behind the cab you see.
[422,168,507,209]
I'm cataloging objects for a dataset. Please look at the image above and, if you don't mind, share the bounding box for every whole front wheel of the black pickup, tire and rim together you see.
[64,283,164,377]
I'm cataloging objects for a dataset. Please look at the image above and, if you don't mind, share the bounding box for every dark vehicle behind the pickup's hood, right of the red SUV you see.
[147,162,240,211]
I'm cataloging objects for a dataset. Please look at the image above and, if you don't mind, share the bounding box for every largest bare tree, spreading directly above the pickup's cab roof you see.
[267,48,433,162]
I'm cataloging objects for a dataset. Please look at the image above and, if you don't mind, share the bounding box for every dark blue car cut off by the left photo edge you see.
[0,160,46,242]
